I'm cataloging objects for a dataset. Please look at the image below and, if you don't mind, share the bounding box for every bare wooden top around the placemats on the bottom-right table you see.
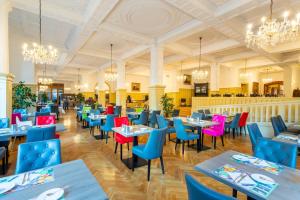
[195,151,300,200]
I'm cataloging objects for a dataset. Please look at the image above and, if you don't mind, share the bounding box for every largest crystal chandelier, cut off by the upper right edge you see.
[245,0,300,48]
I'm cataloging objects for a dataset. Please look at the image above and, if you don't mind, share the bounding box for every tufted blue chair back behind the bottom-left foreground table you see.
[16,139,61,174]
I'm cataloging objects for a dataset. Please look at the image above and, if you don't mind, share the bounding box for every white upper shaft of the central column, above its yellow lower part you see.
[150,44,164,86]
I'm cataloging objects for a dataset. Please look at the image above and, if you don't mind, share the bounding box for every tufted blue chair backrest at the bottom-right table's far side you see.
[254,138,298,168]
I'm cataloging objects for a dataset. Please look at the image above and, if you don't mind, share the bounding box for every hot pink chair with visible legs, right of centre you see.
[202,115,226,149]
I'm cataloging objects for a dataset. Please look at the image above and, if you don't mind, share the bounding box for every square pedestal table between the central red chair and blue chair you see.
[112,125,153,169]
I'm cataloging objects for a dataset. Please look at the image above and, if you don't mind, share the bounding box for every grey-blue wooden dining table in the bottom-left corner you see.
[0,160,108,200]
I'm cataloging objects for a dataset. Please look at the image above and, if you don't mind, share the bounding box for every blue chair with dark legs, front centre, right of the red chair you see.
[132,128,167,181]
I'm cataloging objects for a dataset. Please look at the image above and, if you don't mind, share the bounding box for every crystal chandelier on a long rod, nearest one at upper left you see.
[22,0,58,64]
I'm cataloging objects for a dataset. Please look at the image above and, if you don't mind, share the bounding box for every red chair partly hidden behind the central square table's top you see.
[114,117,133,160]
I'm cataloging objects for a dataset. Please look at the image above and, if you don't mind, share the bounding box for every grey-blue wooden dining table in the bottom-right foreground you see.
[195,150,300,200]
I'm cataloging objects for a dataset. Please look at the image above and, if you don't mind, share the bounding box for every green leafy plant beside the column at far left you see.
[12,81,36,109]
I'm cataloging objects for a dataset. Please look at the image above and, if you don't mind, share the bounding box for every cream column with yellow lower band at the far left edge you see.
[0,0,13,117]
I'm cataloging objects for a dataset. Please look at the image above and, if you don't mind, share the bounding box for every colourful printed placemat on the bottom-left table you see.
[0,168,54,197]
